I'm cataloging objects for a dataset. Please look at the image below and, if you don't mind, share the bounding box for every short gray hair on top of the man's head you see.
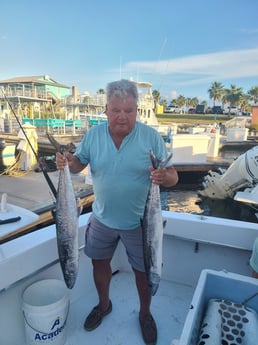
[106,79,138,103]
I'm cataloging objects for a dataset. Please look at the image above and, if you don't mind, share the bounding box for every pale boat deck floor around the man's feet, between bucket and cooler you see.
[65,272,194,345]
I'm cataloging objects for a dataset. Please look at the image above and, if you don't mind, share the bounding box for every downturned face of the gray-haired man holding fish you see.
[106,96,137,136]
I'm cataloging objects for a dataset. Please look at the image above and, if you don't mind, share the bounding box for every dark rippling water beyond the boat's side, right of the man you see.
[161,189,258,223]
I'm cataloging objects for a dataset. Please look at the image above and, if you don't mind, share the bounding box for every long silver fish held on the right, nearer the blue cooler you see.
[142,150,172,296]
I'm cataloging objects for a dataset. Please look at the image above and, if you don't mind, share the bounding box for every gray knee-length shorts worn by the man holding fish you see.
[84,215,145,272]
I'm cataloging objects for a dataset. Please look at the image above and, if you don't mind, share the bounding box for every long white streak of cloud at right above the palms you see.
[123,48,258,85]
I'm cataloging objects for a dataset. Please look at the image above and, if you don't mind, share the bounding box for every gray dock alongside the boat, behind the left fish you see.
[0,171,94,244]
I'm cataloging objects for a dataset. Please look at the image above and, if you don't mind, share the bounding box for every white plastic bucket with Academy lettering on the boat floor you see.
[22,279,69,345]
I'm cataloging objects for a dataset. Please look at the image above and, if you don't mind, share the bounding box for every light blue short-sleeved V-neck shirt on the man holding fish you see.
[75,122,171,230]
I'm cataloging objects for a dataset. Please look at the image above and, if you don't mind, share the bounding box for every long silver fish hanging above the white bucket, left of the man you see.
[48,135,79,289]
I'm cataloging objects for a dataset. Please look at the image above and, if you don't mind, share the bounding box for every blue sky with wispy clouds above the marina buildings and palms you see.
[0,0,258,101]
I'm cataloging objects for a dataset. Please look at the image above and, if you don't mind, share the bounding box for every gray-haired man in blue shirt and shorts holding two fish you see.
[56,80,178,345]
